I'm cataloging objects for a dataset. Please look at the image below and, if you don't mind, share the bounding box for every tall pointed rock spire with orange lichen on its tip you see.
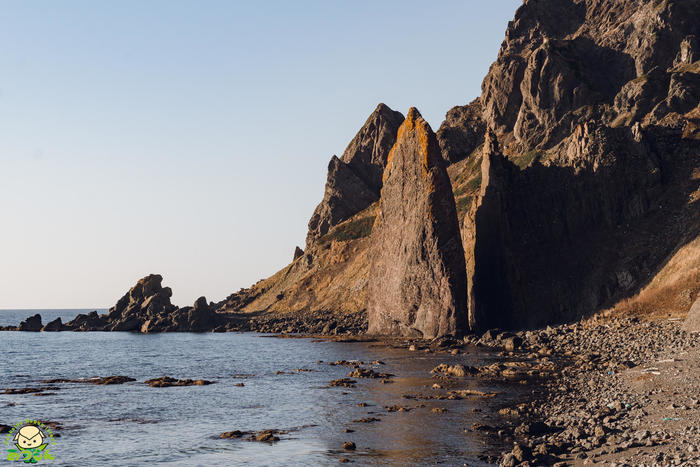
[367,108,466,338]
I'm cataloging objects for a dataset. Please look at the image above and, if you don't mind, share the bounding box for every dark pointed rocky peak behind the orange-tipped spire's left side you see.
[306,104,403,245]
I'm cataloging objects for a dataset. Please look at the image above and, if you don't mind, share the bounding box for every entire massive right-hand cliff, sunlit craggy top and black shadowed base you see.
[462,0,700,329]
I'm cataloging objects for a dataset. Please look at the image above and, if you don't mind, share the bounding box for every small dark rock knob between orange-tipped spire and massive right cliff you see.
[437,98,486,163]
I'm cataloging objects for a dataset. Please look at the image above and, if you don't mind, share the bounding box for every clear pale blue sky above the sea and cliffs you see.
[0,0,522,309]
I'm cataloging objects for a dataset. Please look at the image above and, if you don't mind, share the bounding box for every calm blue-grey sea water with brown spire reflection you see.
[0,310,519,465]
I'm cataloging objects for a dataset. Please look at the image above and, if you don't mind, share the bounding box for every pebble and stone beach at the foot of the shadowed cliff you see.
[486,318,700,466]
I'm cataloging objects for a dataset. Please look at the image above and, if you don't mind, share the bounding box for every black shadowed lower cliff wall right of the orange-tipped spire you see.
[462,124,700,330]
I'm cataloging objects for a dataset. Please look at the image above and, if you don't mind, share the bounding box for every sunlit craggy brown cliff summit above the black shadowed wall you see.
[482,0,700,149]
